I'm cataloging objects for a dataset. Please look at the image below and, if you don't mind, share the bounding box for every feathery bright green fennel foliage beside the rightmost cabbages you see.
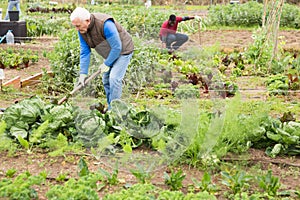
[214,95,268,155]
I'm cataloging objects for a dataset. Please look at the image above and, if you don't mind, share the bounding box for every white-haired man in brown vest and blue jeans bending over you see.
[70,7,134,110]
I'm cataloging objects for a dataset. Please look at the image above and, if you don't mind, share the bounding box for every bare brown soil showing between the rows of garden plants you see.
[0,30,300,199]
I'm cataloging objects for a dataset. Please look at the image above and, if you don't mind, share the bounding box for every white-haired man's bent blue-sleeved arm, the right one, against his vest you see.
[104,20,122,67]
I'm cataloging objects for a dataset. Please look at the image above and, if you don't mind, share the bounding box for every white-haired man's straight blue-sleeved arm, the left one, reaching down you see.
[78,31,91,74]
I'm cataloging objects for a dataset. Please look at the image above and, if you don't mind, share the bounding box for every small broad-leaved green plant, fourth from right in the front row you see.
[164,169,186,190]
